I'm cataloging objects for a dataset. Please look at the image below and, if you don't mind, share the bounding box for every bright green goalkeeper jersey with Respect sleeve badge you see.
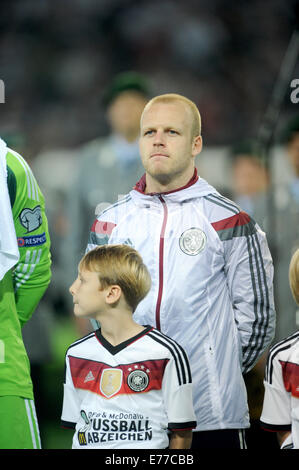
[0,149,51,399]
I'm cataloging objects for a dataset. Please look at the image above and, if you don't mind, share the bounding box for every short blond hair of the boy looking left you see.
[79,245,151,312]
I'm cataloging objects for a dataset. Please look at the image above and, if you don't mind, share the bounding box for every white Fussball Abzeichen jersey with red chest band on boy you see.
[61,326,196,449]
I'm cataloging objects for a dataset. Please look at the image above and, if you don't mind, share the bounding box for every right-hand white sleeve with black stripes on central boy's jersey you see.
[162,345,196,431]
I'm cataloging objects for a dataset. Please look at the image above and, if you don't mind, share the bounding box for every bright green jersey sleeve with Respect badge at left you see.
[6,150,51,326]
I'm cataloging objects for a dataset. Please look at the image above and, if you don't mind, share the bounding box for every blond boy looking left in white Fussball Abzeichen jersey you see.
[61,245,196,449]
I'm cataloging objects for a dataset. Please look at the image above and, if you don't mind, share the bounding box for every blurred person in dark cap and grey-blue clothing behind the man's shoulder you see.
[61,72,150,328]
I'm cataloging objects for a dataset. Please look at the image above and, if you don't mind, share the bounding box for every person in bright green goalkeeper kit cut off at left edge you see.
[0,139,51,449]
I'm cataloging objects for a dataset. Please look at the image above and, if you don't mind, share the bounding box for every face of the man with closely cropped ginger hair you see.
[139,101,201,184]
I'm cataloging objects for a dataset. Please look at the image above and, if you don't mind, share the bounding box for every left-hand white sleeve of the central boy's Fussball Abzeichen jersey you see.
[61,356,80,429]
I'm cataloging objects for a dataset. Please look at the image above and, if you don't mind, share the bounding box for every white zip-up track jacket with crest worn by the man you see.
[87,170,275,430]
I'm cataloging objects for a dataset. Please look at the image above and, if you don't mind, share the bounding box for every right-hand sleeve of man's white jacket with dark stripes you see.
[217,212,275,373]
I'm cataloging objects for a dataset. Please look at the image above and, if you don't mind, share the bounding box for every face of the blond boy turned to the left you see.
[70,270,106,318]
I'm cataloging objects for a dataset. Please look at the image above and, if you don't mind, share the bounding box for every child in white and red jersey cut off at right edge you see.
[260,249,299,449]
